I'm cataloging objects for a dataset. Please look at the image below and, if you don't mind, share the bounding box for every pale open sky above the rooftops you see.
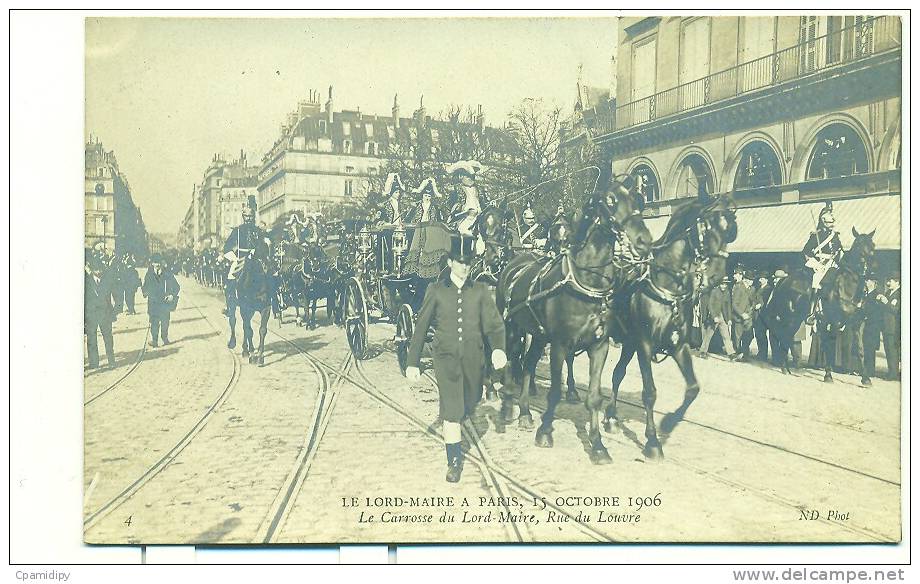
[86,17,617,232]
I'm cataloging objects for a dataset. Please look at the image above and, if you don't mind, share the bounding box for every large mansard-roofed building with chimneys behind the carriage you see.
[258,87,512,225]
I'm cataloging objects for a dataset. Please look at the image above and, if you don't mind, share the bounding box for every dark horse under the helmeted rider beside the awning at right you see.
[761,228,875,383]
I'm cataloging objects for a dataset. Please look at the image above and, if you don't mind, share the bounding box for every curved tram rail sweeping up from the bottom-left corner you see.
[83,296,242,533]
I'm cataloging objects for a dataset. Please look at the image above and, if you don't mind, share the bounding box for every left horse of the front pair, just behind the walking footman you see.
[496,178,652,447]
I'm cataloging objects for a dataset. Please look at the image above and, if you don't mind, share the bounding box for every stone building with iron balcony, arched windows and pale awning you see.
[590,15,902,268]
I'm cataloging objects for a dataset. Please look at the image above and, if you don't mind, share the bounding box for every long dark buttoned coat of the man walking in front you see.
[408,275,505,422]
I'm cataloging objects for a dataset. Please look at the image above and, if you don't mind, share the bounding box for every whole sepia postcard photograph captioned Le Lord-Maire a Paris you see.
[75,11,910,545]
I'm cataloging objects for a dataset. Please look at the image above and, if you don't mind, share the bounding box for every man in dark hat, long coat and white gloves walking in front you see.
[406,234,507,483]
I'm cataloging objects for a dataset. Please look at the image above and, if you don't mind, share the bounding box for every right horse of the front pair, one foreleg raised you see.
[604,198,738,461]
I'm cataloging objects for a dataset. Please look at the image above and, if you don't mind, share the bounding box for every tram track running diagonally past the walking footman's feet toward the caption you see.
[270,324,615,542]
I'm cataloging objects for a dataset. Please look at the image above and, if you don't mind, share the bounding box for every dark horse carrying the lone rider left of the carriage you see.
[227,240,273,365]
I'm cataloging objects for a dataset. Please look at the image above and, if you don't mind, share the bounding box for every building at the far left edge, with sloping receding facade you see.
[83,139,147,257]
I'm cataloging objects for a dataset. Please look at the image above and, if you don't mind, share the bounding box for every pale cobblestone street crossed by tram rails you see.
[84,278,901,544]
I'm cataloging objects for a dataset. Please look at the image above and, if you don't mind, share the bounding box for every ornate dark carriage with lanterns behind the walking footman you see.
[340,223,432,359]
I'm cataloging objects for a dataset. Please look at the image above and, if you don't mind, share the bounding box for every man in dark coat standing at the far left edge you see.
[83,257,115,369]
